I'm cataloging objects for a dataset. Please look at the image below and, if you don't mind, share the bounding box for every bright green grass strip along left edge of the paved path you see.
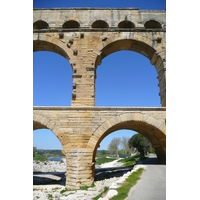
[111,168,144,200]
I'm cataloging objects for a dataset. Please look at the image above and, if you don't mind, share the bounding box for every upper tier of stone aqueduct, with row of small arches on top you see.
[33,8,166,107]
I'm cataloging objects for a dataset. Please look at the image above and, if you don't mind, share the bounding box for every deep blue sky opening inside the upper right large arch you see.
[95,50,161,107]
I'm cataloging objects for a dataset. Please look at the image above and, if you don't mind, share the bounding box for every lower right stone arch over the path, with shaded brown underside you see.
[87,113,166,162]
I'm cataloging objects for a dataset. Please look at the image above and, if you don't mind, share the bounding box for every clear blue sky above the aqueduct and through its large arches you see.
[33,0,166,149]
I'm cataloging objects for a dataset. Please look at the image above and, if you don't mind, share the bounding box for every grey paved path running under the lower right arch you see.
[126,157,166,200]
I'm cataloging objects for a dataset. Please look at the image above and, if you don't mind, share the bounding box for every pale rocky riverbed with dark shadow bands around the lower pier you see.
[33,159,145,200]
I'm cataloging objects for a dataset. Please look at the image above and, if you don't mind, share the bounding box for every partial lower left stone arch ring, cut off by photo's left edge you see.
[33,114,67,153]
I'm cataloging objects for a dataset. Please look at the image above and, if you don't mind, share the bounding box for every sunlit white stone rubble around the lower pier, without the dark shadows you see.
[33,160,145,200]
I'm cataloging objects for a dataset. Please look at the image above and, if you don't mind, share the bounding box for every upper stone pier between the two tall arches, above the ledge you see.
[68,32,99,106]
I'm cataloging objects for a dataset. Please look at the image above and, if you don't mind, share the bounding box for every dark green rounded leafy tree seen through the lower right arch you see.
[129,133,151,156]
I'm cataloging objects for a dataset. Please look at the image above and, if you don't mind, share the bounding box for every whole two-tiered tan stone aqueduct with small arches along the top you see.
[33,8,166,189]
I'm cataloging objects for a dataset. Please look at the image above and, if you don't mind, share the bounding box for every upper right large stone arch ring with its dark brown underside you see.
[93,32,166,107]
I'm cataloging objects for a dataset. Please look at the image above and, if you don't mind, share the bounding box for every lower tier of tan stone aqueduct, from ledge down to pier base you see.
[33,107,166,189]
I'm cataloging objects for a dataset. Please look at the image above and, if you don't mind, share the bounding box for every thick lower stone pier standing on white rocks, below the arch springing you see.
[65,148,94,189]
